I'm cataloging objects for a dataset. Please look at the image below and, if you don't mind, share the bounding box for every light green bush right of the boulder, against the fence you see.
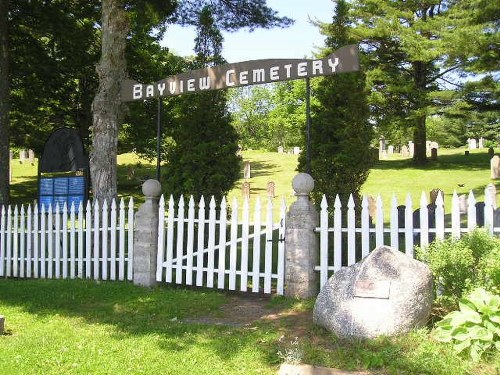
[417,229,500,301]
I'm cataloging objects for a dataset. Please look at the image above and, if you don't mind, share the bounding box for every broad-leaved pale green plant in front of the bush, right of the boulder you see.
[434,288,500,362]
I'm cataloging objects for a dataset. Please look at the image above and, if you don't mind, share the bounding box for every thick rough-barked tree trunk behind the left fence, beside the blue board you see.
[90,0,129,203]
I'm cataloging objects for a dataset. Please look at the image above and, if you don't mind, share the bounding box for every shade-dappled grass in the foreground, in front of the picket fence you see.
[0,279,500,375]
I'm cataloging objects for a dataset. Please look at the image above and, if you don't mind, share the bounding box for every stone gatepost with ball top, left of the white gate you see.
[134,180,161,287]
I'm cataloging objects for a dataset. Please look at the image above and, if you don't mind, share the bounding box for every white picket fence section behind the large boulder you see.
[316,191,500,286]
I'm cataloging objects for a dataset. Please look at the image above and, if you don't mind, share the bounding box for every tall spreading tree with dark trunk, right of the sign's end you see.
[352,0,498,164]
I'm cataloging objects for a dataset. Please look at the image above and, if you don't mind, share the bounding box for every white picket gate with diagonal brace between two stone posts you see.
[156,196,287,295]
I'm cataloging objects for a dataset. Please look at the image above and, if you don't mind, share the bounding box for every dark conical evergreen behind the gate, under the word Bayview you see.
[165,6,240,201]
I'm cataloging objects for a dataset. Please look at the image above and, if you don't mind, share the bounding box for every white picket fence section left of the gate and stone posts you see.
[0,199,134,280]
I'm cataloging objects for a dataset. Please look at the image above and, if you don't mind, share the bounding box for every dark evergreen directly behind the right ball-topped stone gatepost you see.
[299,0,373,209]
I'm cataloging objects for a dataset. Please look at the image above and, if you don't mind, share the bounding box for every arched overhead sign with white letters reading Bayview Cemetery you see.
[121,45,359,102]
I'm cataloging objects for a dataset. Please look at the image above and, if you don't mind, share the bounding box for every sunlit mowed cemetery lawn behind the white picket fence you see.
[11,148,500,209]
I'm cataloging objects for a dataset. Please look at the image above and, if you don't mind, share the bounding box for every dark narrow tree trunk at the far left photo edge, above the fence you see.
[0,0,10,205]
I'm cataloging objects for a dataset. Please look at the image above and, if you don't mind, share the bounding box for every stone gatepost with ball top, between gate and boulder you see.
[285,173,319,298]
